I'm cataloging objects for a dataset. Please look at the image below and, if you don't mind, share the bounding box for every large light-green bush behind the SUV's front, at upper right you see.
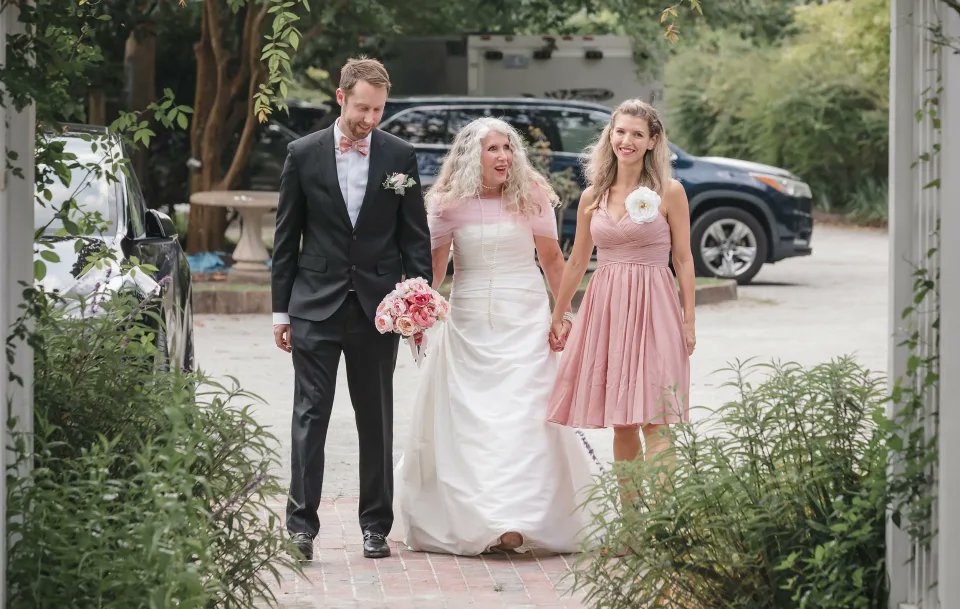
[666,0,890,217]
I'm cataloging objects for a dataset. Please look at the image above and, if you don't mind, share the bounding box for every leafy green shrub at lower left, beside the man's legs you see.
[7,293,297,609]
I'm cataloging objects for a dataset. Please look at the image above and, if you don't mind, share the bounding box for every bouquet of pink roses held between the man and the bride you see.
[374,277,450,366]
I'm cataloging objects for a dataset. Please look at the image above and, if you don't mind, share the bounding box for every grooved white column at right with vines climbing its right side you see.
[887,0,944,609]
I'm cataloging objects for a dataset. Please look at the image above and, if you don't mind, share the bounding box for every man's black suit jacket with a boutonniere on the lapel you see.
[272,125,432,321]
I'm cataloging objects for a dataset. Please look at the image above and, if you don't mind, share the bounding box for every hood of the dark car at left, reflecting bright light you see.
[34,237,157,298]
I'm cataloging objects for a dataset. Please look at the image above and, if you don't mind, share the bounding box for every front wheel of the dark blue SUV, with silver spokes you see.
[690,207,768,285]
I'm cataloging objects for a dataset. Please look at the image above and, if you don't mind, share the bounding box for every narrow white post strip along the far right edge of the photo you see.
[937,7,960,609]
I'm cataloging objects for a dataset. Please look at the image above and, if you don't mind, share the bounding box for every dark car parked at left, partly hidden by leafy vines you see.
[34,125,193,369]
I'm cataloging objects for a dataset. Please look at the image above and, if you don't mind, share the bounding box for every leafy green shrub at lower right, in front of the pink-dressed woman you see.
[575,358,887,609]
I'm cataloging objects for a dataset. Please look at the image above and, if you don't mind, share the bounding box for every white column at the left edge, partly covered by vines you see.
[0,4,35,609]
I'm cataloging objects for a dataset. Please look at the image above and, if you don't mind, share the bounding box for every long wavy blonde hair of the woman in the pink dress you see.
[584,99,672,212]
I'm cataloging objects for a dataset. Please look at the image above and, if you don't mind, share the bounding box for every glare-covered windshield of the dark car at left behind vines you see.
[33,137,122,237]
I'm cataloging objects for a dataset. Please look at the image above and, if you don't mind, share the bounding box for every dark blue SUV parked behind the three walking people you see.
[249,96,813,284]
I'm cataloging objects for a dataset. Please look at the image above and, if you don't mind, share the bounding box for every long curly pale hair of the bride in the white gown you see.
[427,117,559,217]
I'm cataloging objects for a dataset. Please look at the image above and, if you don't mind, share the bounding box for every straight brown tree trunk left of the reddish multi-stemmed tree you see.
[124,22,161,207]
